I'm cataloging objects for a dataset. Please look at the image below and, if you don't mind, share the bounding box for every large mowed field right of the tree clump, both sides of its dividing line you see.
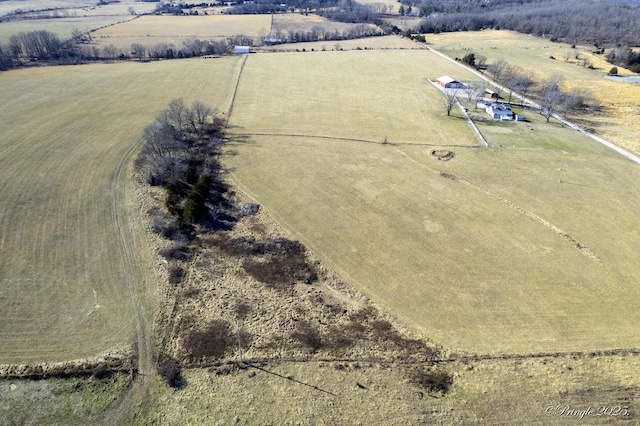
[227,51,640,353]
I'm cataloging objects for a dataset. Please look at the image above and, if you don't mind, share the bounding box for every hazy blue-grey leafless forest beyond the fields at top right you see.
[402,0,640,47]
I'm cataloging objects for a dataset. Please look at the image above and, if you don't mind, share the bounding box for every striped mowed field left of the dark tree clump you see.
[0,57,241,363]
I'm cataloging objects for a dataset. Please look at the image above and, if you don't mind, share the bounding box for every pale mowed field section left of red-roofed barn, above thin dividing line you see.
[230,50,475,145]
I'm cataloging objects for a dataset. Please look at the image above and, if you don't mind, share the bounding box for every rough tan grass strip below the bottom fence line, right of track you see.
[137,356,640,426]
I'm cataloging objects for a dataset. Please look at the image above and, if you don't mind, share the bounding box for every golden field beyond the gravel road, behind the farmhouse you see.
[426,30,640,155]
